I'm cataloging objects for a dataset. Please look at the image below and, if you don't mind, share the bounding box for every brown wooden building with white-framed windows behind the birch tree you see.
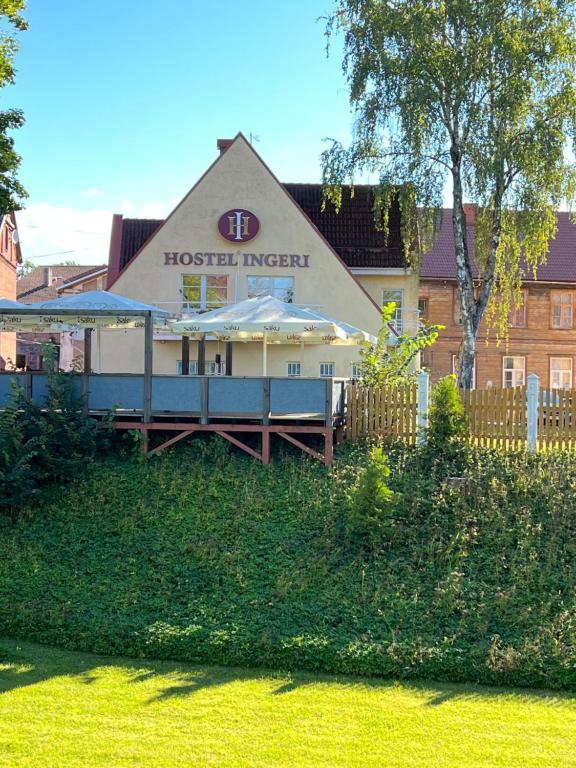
[419,206,576,389]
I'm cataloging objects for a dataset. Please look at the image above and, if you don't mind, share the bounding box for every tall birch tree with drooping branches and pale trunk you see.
[322,0,576,388]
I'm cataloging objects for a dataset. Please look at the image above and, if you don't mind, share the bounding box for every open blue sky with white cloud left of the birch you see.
[9,0,352,264]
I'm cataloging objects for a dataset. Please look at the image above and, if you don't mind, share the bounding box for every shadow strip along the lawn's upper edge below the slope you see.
[0,637,576,707]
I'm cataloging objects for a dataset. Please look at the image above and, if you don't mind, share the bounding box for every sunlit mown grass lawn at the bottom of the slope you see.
[0,638,576,768]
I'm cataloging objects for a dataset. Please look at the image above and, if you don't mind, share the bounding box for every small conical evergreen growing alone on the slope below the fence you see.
[345,446,399,554]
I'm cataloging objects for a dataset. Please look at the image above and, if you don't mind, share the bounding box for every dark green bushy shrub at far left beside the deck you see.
[0,366,109,517]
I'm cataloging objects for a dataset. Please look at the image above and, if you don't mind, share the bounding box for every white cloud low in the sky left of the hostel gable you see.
[16,200,178,266]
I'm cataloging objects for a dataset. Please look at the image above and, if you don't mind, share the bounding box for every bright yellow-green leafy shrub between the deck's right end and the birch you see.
[360,301,444,387]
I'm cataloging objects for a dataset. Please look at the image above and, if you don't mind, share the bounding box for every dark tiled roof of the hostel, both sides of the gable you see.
[119,184,406,270]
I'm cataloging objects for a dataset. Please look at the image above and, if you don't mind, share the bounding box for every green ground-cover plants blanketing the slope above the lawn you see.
[0,438,576,690]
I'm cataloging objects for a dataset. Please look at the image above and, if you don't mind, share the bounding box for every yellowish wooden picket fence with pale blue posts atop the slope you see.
[346,376,576,450]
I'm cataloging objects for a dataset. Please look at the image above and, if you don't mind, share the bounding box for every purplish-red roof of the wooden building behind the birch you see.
[420,208,576,283]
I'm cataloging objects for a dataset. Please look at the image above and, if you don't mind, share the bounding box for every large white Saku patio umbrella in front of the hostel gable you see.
[170,296,375,375]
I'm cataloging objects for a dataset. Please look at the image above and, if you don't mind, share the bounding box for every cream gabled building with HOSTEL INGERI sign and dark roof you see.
[102,134,418,377]
